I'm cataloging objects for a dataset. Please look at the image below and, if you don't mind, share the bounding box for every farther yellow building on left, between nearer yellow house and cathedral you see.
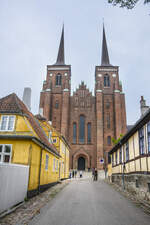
[36,115,70,180]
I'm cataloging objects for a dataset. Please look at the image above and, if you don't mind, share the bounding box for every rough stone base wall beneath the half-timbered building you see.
[111,174,150,202]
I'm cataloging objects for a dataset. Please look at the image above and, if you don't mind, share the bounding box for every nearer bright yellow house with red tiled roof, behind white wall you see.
[0,94,61,196]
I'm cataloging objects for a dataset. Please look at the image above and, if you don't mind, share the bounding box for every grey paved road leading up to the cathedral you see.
[30,180,150,225]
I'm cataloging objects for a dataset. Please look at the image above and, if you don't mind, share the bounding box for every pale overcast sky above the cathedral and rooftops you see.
[0,0,150,124]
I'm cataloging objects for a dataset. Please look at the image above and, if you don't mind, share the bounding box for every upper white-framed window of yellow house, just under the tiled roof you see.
[0,116,15,131]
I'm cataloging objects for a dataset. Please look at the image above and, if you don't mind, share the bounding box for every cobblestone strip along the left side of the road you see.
[0,180,70,225]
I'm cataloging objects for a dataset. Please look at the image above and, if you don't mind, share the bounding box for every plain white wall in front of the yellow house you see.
[0,163,29,213]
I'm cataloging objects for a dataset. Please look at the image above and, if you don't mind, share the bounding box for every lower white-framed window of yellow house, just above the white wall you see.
[0,145,12,163]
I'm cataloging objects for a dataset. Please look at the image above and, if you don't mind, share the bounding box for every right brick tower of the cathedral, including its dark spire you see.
[95,25,126,169]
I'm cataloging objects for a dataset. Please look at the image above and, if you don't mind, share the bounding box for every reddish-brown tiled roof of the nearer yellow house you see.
[0,93,59,155]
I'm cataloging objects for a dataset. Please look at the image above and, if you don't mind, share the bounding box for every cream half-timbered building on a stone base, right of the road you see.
[109,109,150,200]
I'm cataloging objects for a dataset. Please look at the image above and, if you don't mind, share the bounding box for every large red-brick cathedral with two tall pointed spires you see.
[39,26,126,170]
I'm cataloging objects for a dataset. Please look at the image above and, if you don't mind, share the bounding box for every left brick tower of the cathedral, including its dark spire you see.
[40,26,71,137]
